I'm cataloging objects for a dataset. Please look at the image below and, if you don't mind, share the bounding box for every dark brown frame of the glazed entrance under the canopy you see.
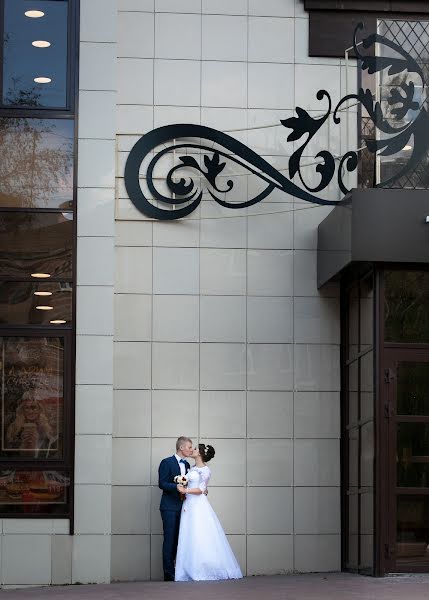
[340,263,429,577]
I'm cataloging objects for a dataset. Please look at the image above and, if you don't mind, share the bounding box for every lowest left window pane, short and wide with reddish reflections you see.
[0,469,70,514]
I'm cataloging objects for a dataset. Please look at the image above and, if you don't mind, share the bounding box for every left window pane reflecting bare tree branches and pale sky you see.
[0,117,74,210]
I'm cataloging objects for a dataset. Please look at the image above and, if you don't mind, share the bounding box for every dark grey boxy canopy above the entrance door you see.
[317,188,429,287]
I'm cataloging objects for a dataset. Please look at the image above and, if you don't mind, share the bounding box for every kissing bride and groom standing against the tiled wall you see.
[158,437,243,581]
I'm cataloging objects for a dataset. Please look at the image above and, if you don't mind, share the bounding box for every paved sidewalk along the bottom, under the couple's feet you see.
[4,573,429,600]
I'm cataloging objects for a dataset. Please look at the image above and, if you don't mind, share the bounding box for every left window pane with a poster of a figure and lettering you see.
[0,337,64,460]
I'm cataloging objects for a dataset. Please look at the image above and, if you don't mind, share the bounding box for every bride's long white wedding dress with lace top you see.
[175,466,243,581]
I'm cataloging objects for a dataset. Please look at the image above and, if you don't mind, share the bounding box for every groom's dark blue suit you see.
[158,455,190,581]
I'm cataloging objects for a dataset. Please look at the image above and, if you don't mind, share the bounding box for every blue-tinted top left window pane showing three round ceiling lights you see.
[2,0,68,108]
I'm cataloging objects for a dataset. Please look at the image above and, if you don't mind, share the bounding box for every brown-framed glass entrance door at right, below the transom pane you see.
[383,348,429,572]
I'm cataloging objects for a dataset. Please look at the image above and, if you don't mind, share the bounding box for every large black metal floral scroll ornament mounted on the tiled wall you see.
[125,24,429,220]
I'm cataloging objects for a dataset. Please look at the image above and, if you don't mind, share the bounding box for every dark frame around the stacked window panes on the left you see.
[0,0,80,524]
